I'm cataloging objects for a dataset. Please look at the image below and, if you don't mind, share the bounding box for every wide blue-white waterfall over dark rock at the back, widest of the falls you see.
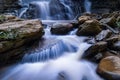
[19,0,74,20]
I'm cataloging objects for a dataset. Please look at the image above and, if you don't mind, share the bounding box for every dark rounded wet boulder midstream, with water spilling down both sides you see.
[51,23,73,35]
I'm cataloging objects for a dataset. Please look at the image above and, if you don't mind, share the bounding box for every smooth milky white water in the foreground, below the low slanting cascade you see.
[0,43,102,80]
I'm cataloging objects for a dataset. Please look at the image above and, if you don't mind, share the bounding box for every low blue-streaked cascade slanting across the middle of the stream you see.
[22,36,85,63]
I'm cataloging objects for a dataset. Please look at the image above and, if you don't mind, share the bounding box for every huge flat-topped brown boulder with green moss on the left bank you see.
[0,20,44,63]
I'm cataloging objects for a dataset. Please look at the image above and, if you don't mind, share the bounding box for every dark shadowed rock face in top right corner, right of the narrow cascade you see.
[91,0,120,14]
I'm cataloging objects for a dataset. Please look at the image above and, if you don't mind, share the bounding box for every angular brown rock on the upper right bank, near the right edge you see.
[100,17,116,28]
